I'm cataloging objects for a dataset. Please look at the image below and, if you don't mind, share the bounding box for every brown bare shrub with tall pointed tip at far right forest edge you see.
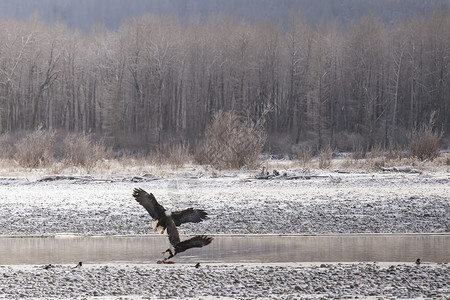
[409,112,442,161]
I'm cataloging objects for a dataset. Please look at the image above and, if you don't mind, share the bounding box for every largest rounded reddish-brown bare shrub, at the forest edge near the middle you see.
[195,111,266,169]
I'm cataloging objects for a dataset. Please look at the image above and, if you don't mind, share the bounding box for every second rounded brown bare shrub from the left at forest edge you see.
[62,133,109,172]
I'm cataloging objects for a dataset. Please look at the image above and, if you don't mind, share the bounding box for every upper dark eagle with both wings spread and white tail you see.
[133,189,208,234]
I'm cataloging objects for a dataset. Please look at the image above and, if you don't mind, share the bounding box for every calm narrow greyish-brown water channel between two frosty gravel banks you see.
[0,234,450,265]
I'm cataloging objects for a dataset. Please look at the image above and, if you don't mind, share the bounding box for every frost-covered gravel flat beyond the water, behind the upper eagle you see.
[0,173,450,235]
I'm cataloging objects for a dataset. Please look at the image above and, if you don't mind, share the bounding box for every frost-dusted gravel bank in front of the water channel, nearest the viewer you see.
[0,263,450,299]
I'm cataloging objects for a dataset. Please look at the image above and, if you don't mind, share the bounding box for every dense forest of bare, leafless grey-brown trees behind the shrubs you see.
[0,10,450,153]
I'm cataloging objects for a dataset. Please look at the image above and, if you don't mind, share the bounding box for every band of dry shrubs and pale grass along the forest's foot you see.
[0,124,450,176]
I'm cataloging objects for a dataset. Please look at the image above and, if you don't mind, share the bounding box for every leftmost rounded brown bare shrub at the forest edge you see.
[14,128,55,168]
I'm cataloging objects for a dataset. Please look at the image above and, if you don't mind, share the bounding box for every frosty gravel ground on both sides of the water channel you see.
[0,169,450,299]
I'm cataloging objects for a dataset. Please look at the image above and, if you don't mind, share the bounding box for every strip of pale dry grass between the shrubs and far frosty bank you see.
[0,153,450,178]
